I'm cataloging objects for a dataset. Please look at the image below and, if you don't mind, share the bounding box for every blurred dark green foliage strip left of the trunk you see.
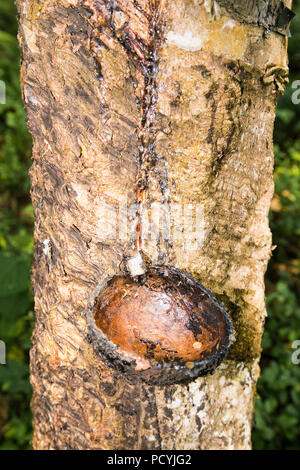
[0,0,33,449]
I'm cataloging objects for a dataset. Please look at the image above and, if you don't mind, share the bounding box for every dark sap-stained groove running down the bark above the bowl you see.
[85,0,166,254]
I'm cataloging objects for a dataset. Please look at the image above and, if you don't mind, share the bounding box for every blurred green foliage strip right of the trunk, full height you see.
[253,2,300,450]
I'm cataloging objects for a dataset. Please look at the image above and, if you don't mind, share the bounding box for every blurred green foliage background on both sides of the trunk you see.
[0,0,300,450]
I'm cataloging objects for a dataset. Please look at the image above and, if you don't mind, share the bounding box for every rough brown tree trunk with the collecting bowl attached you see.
[17,0,292,450]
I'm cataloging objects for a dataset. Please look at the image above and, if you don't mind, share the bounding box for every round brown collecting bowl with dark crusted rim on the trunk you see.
[89,266,233,385]
